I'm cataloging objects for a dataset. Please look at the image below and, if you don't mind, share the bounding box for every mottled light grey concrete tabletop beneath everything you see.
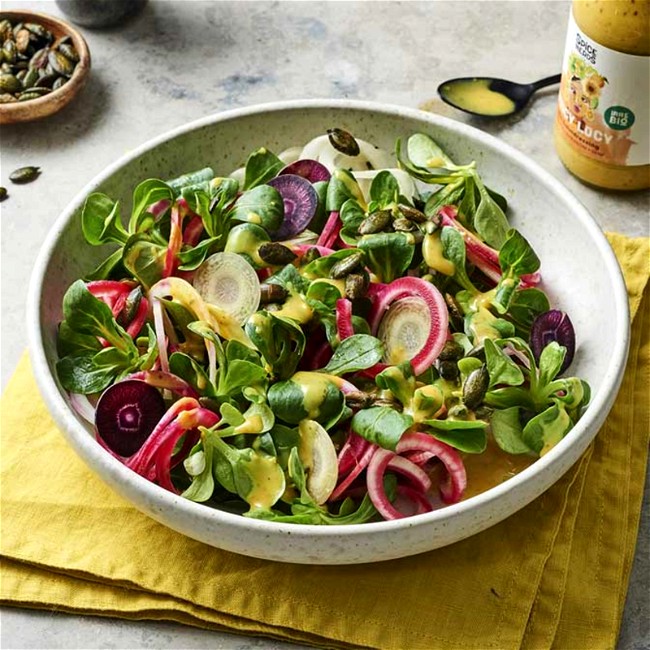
[0,0,650,650]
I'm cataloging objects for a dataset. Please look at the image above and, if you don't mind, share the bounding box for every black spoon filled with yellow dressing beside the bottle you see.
[438,74,562,117]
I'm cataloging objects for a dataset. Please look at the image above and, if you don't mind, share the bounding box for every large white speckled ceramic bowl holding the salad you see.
[28,100,629,564]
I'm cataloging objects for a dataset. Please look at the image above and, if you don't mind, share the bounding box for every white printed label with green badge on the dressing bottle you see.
[557,13,650,166]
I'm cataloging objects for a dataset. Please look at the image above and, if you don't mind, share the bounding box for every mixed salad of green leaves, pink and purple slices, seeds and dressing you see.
[56,128,590,525]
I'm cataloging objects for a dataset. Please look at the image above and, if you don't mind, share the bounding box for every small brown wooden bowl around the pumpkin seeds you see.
[0,11,90,124]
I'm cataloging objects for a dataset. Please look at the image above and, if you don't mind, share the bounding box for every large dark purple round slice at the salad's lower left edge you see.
[95,379,167,457]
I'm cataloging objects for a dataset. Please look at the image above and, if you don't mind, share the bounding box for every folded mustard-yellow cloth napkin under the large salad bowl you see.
[0,235,650,650]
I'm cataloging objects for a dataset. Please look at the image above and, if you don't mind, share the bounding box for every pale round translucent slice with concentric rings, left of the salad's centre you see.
[194,252,260,324]
